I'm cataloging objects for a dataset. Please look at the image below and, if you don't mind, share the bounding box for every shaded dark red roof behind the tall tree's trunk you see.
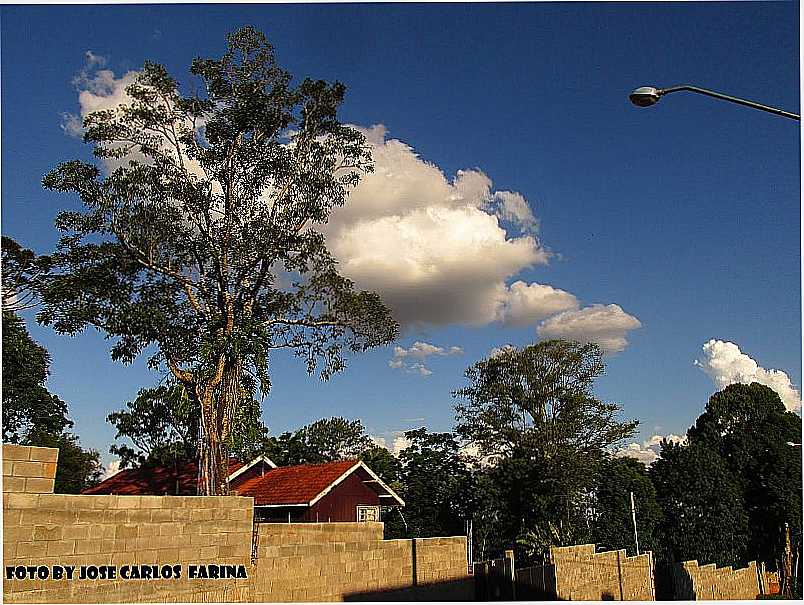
[82,458,243,496]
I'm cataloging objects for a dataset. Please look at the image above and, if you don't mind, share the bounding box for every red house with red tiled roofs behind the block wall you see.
[83,456,405,523]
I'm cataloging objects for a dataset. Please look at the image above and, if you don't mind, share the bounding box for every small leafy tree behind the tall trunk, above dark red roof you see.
[107,384,268,468]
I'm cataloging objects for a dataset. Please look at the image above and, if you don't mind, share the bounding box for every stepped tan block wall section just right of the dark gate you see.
[550,544,654,601]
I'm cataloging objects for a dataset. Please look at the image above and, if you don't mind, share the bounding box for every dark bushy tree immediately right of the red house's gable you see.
[399,428,472,538]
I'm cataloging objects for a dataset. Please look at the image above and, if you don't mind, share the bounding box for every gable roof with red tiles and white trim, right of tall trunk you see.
[236,460,405,506]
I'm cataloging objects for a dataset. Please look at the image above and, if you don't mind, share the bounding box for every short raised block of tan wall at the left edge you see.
[3,445,59,494]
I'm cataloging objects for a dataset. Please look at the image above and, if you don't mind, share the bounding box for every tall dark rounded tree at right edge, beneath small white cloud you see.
[687,382,802,566]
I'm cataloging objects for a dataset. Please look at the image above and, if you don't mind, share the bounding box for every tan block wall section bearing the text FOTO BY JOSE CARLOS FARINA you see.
[3,493,253,603]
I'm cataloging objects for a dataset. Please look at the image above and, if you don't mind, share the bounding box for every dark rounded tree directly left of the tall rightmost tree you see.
[650,441,748,566]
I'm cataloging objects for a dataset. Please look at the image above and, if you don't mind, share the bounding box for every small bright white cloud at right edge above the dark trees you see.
[695,339,801,410]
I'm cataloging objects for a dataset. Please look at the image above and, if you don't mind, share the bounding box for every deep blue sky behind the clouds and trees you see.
[0,2,801,468]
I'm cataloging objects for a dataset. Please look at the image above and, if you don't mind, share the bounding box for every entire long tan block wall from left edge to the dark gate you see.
[3,445,473,603]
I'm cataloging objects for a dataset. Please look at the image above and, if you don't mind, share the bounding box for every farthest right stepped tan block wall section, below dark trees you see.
[674,561,762,601]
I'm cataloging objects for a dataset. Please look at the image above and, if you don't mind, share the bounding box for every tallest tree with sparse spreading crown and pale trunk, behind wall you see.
[38,27,397,494]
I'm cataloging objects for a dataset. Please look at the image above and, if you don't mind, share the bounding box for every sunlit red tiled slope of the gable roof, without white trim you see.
[232,460,357,506]
